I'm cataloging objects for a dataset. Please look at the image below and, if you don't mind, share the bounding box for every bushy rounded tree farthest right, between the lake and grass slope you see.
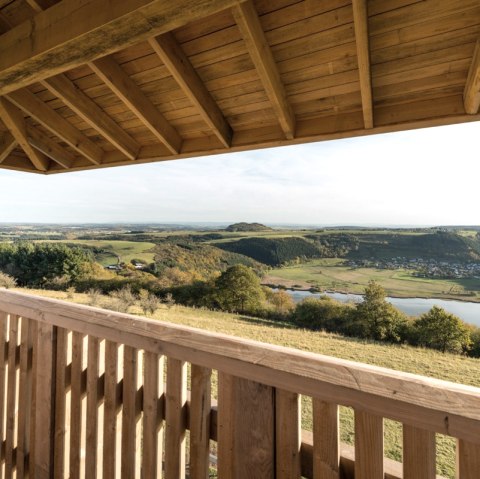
[415,306,470,353]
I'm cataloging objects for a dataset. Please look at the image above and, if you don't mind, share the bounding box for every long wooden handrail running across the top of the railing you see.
[0,290,480,444]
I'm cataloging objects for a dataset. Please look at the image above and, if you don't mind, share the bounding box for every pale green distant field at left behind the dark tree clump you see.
[39,240,155,266]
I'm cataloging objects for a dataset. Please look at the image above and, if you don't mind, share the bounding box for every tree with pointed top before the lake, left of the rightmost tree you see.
[353,281,406,342]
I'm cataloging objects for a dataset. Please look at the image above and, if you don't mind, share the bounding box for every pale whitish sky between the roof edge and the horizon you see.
[0,122,480,226]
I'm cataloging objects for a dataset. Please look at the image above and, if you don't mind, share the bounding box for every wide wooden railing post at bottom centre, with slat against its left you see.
[218,373,275,479]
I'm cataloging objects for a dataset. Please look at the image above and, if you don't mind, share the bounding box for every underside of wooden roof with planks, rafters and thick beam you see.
[0,0,480,173]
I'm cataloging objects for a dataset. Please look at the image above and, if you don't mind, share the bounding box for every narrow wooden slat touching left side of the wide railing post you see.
[217,371,235,479]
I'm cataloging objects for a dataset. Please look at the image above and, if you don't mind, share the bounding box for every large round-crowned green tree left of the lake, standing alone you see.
[214,264,265,312]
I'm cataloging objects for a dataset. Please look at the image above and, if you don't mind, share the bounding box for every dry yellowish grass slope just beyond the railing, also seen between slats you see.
[18,290,480,478]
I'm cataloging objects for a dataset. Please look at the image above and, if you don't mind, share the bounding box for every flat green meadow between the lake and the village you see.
[264,259,480,301]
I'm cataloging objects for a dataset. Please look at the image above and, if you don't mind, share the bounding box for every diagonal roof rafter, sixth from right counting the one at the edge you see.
[42,74,140,160]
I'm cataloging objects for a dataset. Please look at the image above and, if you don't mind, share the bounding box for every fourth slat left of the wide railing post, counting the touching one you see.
[142,351,163,479]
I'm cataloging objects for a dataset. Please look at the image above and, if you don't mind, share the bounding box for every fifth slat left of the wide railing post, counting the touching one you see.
[121,346,137,479]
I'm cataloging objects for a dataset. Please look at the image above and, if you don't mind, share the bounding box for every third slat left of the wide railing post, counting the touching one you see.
[165,358,187,479]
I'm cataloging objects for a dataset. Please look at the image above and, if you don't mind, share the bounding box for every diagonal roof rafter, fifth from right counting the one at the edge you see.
[88,56,182,153]
